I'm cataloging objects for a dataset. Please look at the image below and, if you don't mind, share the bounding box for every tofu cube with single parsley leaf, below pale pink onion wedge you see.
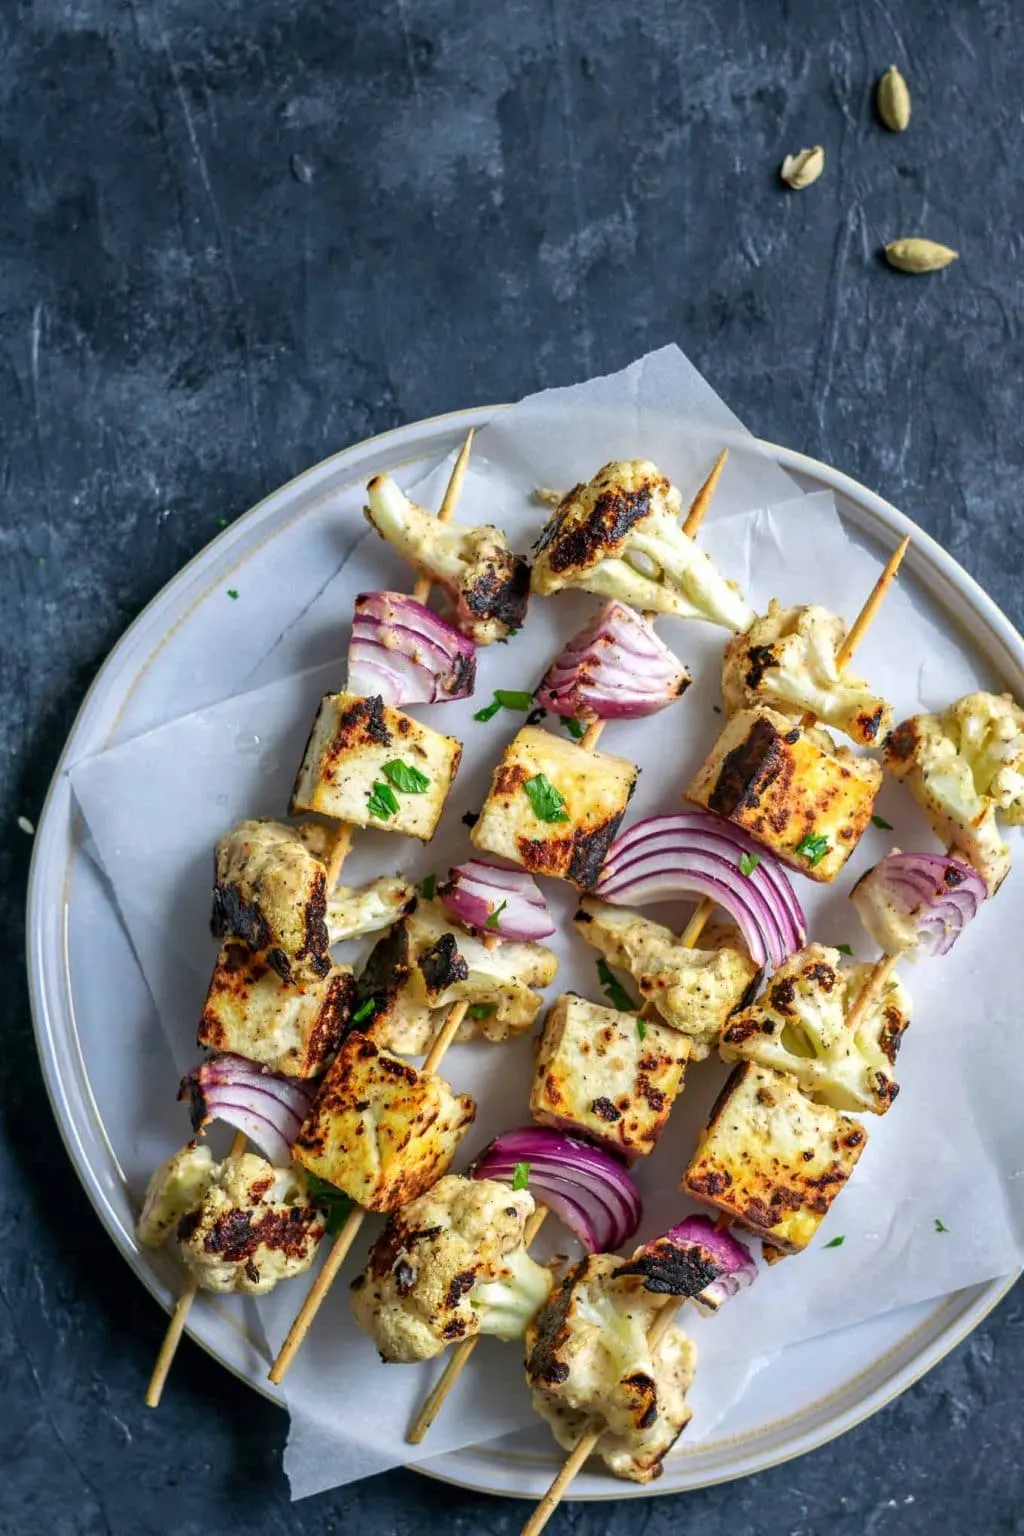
[470,725,637,891]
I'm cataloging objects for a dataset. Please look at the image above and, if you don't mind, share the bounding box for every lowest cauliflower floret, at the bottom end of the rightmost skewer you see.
[527,1253,697,1482]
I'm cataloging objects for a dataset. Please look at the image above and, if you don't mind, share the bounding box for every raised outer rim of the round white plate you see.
[26,406,1024,1502]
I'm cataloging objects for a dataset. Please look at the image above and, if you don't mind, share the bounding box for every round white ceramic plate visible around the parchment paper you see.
[28,409,1024,1499]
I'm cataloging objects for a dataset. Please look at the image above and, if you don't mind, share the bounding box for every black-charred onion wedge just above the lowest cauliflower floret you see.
[616,1217,757,1312]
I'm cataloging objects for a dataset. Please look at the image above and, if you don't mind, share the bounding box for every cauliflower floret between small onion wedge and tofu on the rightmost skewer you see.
[722,945,910,1115]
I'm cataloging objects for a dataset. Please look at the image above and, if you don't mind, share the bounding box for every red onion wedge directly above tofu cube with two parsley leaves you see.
[345,591,476,708]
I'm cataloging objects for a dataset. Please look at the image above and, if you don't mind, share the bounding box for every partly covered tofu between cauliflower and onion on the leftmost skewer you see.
[197,943,356,1077]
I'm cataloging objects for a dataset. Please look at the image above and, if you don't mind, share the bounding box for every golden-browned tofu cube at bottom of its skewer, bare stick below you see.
[292,1031,476,1210]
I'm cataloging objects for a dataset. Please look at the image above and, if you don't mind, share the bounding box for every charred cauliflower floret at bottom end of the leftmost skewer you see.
[138,1147,325,1296]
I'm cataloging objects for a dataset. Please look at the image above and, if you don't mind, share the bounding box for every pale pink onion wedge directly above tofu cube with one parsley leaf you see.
[536,601,692,720]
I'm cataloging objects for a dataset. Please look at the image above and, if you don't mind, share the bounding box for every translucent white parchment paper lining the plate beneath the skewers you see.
[72,353,1024,1496]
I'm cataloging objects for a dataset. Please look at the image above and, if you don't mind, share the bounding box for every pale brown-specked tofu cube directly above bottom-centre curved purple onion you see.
[530,992,689,1157]
